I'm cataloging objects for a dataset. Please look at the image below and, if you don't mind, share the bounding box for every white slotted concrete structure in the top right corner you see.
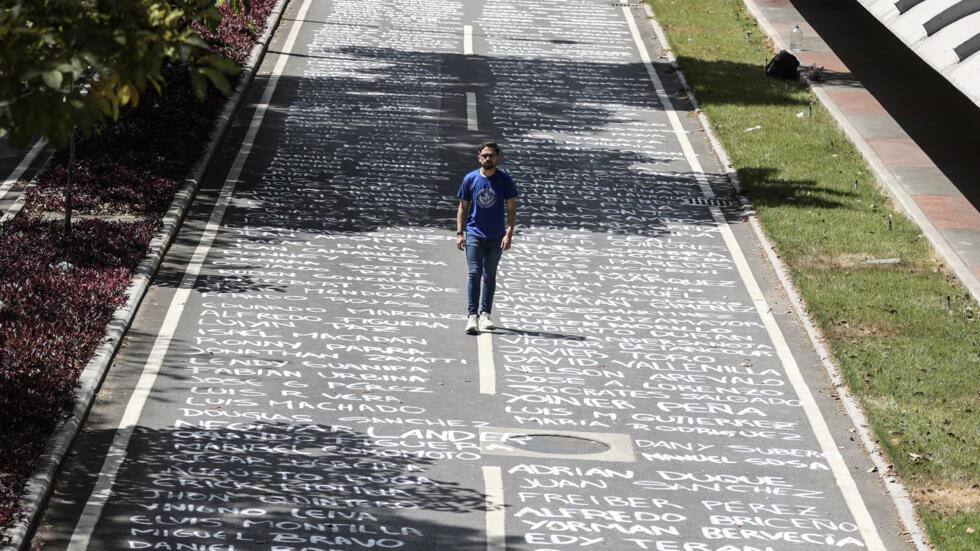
[858,0,980,106]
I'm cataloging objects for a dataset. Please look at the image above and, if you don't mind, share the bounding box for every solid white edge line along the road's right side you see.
[623,7,887,551]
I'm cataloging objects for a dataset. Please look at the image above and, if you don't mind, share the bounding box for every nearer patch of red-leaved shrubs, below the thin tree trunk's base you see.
[0,217,159,536]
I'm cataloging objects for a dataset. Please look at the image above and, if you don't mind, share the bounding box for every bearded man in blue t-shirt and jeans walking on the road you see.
[456,142,517,335]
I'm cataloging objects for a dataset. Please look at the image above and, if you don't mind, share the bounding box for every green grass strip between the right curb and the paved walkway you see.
[648,0,980,551]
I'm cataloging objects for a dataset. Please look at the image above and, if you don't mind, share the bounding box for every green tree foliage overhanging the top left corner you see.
[0,0,235,149]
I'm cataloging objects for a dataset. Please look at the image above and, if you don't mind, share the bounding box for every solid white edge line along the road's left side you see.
[68,0,312,551]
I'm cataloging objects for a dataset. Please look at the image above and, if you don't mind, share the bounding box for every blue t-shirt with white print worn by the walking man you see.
[456,169,517,239]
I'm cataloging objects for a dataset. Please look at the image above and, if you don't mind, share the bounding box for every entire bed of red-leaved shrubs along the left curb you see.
[0,0,274,543]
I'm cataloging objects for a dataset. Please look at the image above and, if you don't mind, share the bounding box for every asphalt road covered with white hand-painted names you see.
[33,0,920,551]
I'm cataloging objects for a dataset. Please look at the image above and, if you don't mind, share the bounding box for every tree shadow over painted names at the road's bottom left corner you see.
[39,424,523,551]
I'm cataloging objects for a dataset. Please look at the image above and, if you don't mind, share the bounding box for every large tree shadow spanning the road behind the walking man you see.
[144,47,736,293]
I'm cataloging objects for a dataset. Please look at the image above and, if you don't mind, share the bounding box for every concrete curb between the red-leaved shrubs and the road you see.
[0,0,288,551]
